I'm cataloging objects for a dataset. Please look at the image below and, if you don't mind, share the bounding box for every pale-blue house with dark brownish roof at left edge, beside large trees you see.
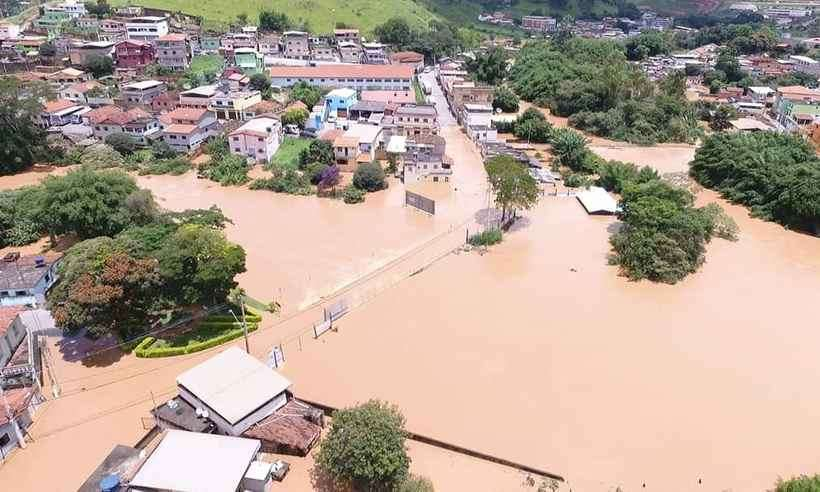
[0,255,61,306]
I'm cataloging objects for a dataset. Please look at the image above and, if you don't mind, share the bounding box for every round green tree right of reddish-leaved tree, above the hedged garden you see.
[157,224,245,304]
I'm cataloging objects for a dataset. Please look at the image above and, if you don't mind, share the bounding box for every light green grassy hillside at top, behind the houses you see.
[111,0,436,35]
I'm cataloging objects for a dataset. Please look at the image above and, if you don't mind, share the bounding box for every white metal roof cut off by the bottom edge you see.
[130,430,261,492]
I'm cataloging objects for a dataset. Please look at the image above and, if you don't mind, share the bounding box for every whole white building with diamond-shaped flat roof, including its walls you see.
[173,346,291,434]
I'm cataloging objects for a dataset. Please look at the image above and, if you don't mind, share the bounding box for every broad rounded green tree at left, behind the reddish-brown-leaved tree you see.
[42,168,137,238]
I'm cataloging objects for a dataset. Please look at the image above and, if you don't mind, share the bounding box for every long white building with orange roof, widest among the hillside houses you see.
[270,64,414,91]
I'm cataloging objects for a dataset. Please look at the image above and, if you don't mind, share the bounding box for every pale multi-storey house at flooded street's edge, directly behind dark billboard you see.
[400,135,453,185]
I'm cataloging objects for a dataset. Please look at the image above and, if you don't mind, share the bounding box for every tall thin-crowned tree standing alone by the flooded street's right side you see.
[484,156,539,220]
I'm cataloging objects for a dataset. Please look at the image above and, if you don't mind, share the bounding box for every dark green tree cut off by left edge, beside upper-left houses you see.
[0,77,53,174]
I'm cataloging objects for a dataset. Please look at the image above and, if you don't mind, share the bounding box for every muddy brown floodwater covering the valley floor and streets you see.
[0,124,820,491]
